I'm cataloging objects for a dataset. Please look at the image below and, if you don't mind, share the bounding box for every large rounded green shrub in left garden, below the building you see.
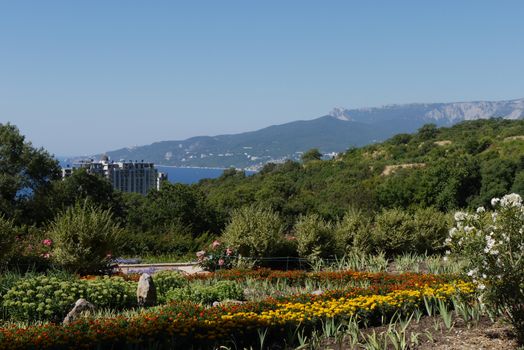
[49,202,123,274]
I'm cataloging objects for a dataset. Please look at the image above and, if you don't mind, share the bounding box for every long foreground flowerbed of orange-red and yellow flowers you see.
[0,276,474,349]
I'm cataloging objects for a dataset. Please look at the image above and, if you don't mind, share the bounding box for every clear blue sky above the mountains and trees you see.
[0,0,524,155]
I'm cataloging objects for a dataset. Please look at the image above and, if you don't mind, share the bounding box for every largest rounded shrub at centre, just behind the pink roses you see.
[222,205,284,258]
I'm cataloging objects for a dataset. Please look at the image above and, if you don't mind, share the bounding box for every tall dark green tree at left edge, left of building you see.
[0,123,60,223]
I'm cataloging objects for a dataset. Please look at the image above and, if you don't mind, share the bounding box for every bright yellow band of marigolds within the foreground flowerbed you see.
[185,281,475,339]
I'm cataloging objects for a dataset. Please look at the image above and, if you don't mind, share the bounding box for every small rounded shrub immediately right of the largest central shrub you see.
[293,214,336,261]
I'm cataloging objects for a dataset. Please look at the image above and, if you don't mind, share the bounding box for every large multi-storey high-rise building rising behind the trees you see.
[62,156,167,195]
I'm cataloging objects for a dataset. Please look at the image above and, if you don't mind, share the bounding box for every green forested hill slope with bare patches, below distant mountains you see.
[198,119,524,218]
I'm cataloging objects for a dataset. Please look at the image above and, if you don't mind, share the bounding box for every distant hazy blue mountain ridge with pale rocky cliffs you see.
[101,98,524,168]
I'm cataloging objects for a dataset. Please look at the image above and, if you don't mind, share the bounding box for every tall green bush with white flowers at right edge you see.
[446,193,524,344]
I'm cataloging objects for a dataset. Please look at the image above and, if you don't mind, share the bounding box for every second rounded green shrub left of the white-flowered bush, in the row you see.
[371,209,416,256]
